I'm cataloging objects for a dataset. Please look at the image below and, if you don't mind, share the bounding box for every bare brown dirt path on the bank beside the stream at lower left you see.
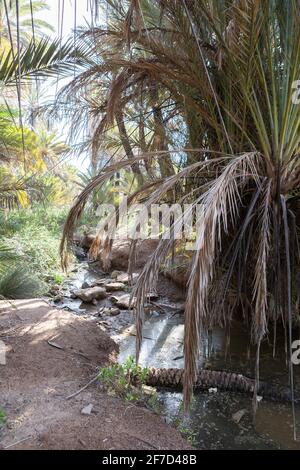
[0,300,190,449]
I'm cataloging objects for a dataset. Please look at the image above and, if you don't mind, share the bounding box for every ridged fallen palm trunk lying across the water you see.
[143,368,299,402]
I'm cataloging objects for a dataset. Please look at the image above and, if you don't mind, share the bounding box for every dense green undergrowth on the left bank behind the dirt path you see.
[0,205,97,298]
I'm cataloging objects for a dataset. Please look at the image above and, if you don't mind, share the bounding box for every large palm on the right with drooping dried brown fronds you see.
[62,0,300,430]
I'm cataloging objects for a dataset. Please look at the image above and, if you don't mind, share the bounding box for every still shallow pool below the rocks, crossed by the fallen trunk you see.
[119,312,300,449]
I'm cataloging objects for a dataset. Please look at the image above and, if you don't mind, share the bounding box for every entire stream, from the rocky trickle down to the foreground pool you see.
[54,262,300,449]
